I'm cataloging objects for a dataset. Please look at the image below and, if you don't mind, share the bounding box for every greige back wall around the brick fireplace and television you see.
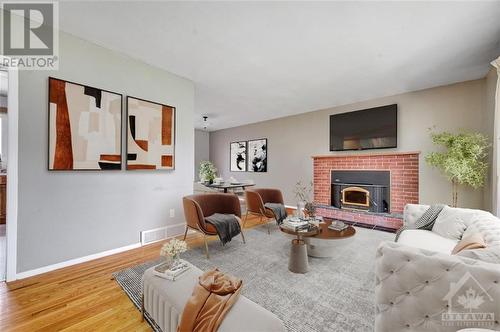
[210,79,493,209]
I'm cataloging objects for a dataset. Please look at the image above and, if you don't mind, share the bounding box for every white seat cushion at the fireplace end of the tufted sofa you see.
[398,229,458,254]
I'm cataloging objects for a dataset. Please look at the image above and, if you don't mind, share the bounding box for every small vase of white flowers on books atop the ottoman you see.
[155,239,189,280]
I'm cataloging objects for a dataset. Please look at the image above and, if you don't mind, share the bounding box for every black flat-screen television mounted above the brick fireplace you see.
[330,104,398,151]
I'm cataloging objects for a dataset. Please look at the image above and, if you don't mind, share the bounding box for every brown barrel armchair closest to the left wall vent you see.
[182,193,245,258]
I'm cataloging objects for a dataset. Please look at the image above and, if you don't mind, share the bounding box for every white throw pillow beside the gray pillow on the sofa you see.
[432,206,473,241]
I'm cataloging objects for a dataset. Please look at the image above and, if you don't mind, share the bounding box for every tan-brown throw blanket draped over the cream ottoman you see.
[177,269,242,332]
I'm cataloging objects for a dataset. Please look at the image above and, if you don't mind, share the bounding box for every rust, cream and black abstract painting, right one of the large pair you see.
[127,97,175,170]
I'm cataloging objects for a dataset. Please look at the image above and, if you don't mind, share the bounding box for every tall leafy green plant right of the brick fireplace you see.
[425,132,490,207]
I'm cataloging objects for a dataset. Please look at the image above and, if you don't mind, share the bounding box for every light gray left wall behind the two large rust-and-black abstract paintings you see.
[17,32,194,272]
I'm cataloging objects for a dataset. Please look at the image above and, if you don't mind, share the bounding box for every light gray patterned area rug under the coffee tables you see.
[115,226,394,332]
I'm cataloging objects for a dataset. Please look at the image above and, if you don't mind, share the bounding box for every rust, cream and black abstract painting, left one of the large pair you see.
[49,77,122,170]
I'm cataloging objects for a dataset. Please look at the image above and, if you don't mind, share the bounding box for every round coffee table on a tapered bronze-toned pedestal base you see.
[280,226,319,273]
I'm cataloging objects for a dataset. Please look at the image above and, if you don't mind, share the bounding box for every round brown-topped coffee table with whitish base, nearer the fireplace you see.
[304,219,356,257]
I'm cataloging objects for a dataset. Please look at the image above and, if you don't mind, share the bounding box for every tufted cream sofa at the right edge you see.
[375,204,500,332]
